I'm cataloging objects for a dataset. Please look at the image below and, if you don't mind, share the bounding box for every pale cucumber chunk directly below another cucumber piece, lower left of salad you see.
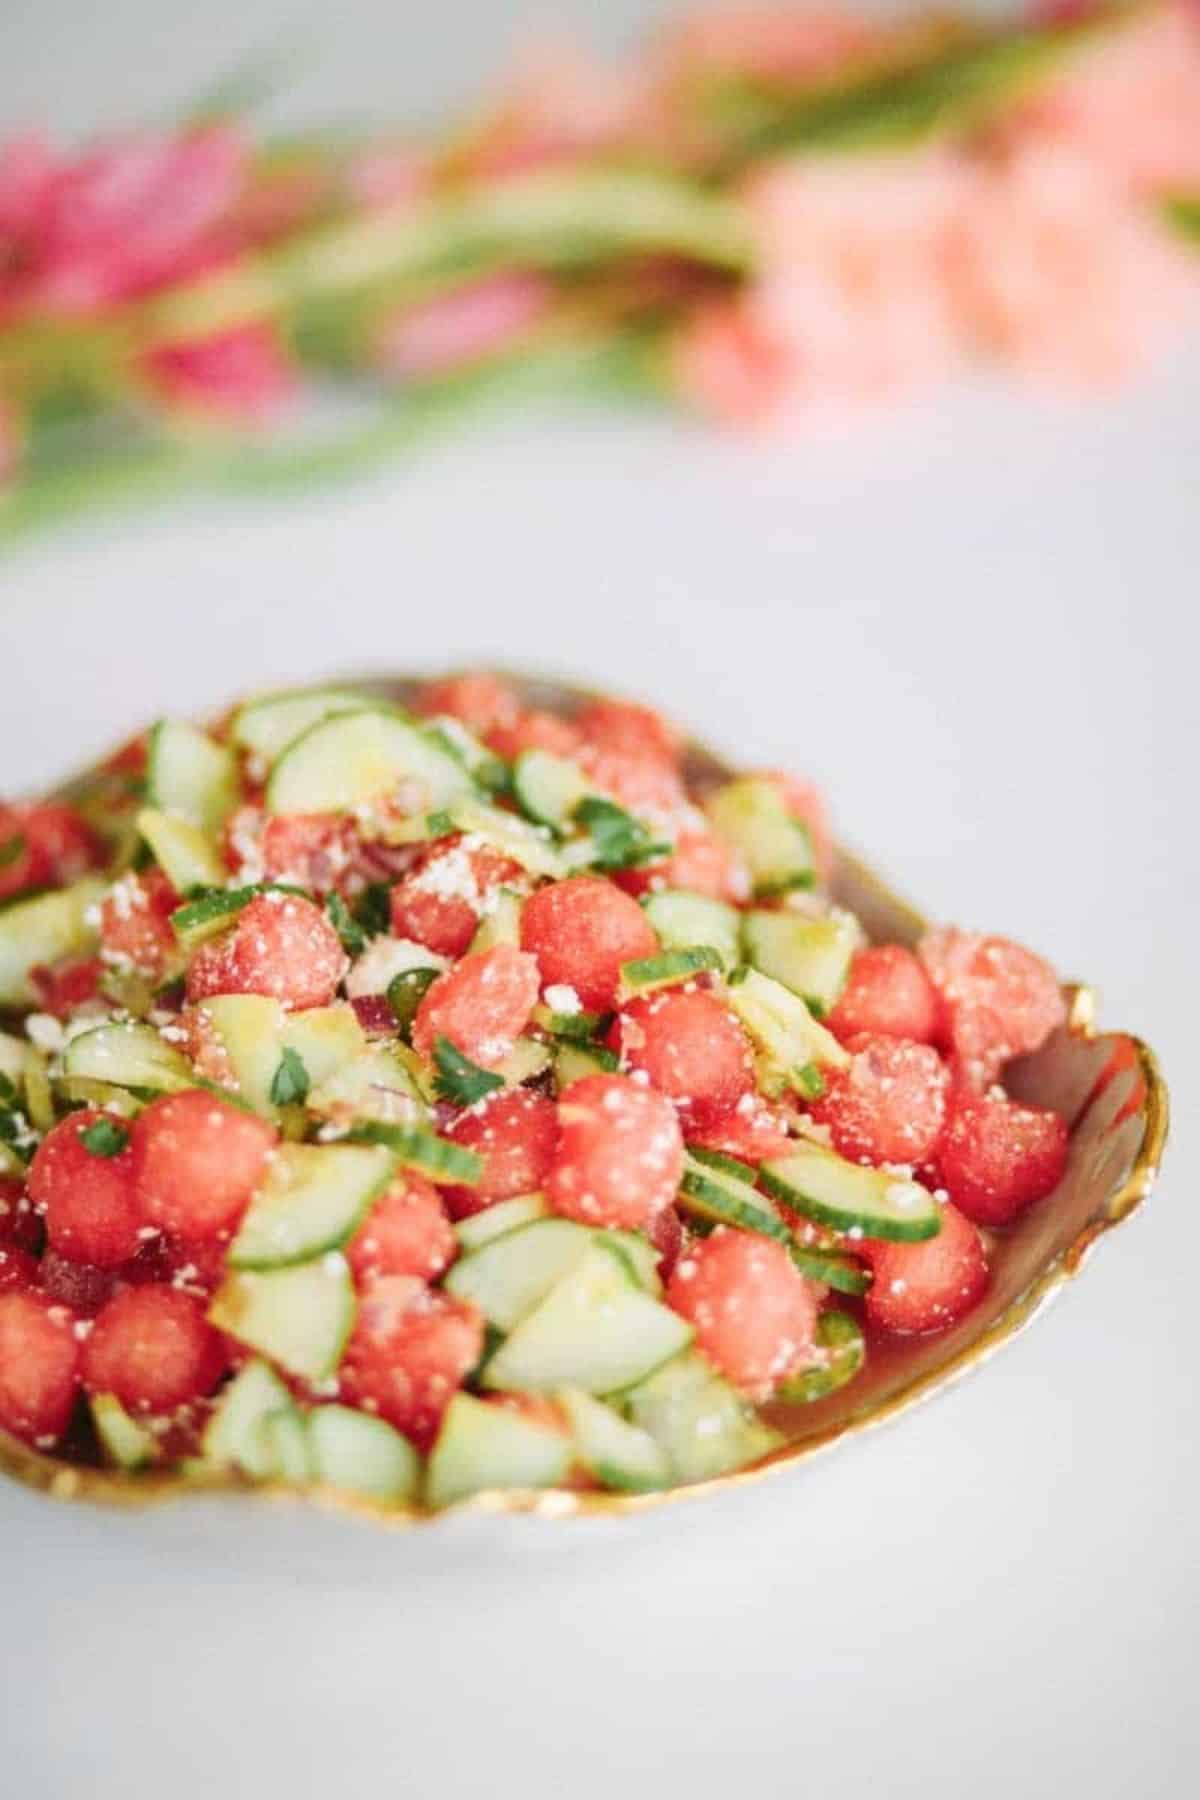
[209,1251,356,1381]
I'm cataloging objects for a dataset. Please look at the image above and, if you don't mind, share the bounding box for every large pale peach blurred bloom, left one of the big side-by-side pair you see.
[676,151,970,419]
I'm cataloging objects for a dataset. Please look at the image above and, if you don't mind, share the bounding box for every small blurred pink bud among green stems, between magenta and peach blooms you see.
[378,270,552,378]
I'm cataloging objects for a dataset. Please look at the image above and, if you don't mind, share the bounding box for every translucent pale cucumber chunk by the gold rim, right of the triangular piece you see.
[626,1350,783,1483]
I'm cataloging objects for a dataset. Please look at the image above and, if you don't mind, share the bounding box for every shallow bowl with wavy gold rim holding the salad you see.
[0,675,1168,1525]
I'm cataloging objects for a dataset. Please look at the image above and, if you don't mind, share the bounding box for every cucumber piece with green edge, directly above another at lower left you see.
[228,1143,396,1269]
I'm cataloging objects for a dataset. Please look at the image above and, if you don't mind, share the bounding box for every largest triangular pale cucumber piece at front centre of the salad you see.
[480,1226,693,1393]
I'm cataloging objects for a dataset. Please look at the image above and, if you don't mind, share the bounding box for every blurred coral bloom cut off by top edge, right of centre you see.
[666,5,883,81]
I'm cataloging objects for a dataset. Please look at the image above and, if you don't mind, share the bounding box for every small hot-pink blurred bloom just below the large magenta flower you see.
[142,326,295,425]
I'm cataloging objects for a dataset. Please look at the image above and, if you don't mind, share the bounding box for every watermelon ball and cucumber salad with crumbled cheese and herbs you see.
[0,673,1069,1508]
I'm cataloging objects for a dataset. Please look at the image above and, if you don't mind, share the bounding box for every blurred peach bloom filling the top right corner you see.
[1006,0,1200,194]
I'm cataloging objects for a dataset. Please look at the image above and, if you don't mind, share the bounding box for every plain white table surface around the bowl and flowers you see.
[0,0,1200,1800]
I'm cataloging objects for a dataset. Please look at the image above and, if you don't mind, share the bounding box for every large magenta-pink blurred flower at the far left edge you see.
[0,126,245,313]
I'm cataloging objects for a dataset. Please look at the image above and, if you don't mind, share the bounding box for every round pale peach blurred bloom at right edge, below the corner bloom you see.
[955,140,1200,382]
